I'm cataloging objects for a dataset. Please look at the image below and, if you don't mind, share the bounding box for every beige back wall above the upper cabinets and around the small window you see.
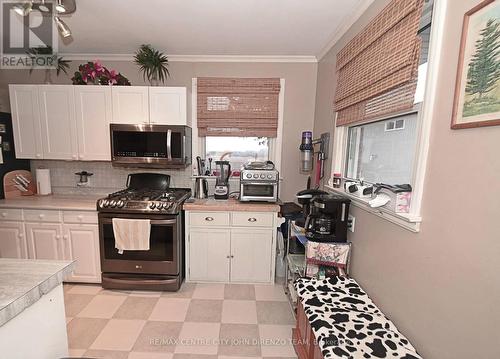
[0,61,317,201]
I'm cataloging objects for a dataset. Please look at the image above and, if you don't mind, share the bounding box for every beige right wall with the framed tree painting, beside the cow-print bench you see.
[315,0,500,359]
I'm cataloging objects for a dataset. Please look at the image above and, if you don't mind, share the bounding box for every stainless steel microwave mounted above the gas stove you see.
[110,124,192,168]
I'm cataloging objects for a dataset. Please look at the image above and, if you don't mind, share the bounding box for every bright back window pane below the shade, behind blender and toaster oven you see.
[205,136,269,171]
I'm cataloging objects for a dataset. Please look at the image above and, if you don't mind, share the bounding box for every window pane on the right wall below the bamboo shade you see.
[346,113,417,185]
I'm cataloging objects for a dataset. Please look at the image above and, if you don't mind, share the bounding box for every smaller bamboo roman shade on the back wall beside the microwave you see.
[197,77,280,137]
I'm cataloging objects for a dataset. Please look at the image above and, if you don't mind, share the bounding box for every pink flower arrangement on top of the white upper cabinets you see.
[71,61,130,86]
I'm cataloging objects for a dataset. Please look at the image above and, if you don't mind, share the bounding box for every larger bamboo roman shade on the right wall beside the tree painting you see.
[334,0,423,126]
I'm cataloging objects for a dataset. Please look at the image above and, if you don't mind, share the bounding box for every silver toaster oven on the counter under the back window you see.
[240,161,279,203]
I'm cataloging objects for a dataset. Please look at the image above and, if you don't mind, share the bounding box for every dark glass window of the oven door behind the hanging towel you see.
[102,223,176,262]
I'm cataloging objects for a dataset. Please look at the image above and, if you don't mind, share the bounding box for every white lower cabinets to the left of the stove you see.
[0,209,101,283]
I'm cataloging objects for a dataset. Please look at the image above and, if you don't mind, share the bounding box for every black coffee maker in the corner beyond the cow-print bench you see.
[304,194,351,242]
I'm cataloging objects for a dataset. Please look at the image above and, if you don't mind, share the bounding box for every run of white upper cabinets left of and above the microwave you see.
[9,85,188,161]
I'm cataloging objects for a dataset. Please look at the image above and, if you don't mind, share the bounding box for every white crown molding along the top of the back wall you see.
[59,53,318,63]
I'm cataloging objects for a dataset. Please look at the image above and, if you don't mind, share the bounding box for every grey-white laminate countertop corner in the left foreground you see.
[0,258,75,326]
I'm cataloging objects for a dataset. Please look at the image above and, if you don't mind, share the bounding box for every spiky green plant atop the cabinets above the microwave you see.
[134,44,170,84]
